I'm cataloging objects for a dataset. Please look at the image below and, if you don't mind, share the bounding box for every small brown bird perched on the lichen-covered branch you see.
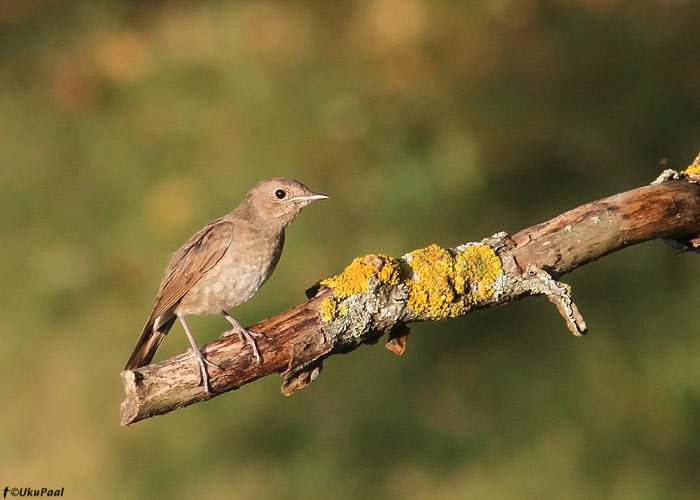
[125,178,328,392]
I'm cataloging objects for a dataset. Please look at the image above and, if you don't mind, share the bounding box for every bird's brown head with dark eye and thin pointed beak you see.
[243,178,328,227]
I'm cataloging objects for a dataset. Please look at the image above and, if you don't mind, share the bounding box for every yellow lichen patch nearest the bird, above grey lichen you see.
[321,254,401,321]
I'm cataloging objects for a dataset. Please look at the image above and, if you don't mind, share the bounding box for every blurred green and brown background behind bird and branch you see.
[0,0,700,499]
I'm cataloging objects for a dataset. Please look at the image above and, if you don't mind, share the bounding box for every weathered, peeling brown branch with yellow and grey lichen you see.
[121,165,700,425]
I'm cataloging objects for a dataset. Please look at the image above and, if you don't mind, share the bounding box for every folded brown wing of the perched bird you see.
[149,218,233,321]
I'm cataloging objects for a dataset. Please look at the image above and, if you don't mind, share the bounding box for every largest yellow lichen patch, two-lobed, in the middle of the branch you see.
[407,245,502,319]
